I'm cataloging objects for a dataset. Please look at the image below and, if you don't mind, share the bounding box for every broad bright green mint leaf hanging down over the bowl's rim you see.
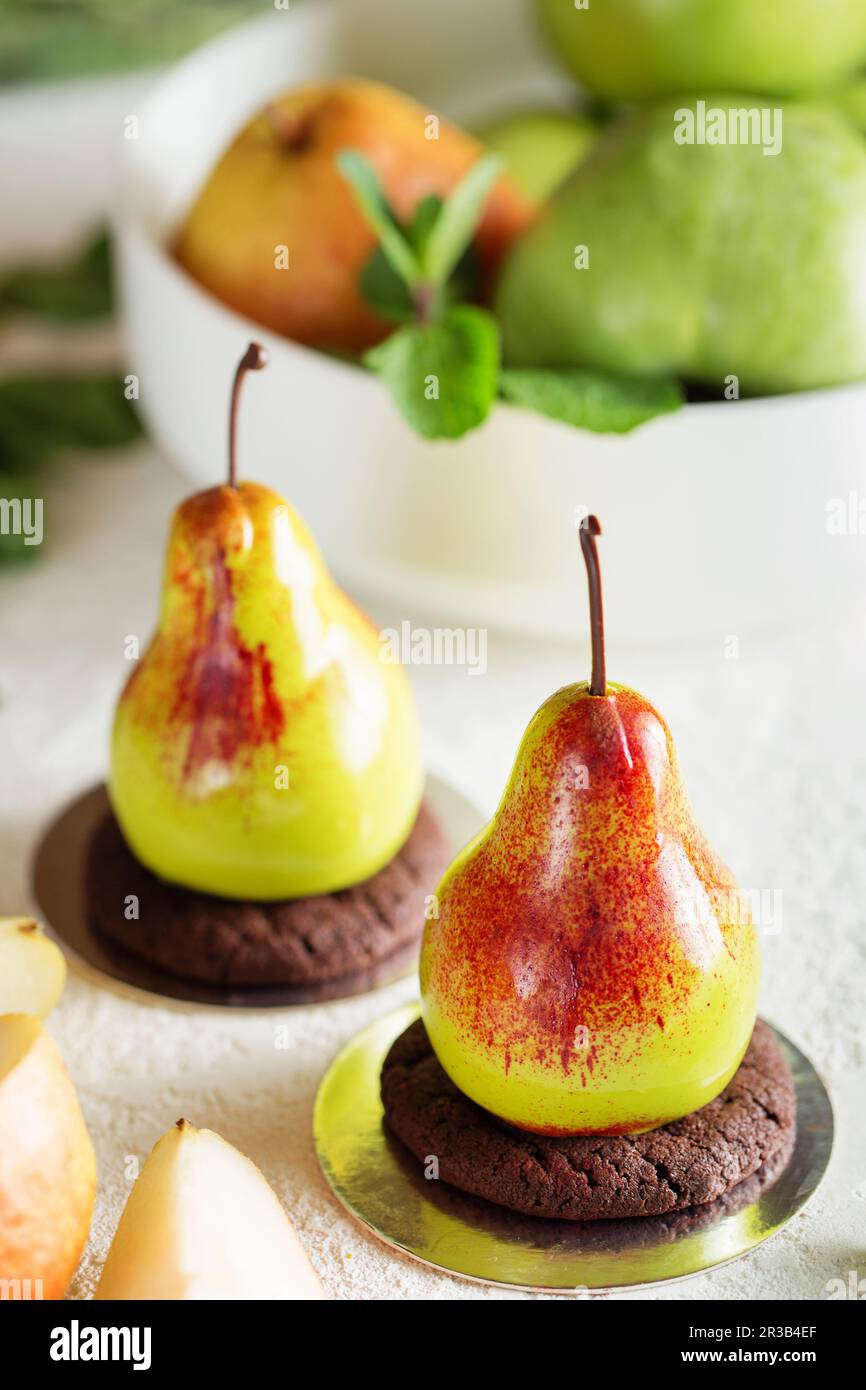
[364,304,499,439]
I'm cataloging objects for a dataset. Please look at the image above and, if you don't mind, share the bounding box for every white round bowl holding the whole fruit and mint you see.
[118,0,866,639]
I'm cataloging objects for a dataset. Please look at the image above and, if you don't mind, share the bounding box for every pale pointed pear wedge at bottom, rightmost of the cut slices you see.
[96,1120,324,1300]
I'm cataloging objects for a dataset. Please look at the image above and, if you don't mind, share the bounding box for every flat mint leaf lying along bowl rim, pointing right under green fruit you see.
[499,367,685,434]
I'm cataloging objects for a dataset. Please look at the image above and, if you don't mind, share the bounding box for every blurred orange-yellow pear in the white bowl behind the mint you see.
[175,79,534,352]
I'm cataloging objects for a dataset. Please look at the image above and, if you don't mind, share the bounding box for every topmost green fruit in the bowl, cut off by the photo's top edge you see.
[535,0,866,100]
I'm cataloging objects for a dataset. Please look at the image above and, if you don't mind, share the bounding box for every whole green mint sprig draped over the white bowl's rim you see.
[336,150,684,439]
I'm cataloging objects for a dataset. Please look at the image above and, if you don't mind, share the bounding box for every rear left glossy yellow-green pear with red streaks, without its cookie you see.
[110,343,423,899]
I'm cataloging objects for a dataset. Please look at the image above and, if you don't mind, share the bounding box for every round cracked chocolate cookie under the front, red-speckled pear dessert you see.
[382,1020,796,1220]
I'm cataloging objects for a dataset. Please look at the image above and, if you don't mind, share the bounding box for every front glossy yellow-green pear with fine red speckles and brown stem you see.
[421,517,760,1134]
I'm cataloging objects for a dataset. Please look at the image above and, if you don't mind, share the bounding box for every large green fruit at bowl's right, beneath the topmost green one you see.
[495,95,866,396]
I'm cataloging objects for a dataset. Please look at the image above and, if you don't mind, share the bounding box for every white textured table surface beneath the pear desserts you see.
[0,448,866,1300]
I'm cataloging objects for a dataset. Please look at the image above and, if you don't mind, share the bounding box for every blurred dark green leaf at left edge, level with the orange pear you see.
[0,232,113,322]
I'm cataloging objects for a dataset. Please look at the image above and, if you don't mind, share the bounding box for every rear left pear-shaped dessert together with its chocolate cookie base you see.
[90,343,446,984]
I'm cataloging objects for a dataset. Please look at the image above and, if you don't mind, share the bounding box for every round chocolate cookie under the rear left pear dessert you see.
[85,803,450,988]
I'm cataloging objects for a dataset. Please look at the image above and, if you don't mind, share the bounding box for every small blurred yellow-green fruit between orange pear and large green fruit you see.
[478,110,598,203]
